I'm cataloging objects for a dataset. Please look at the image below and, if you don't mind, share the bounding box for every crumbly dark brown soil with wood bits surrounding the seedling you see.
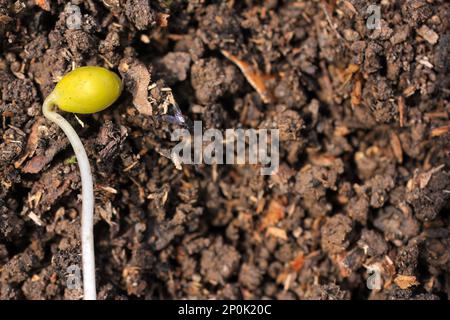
[0,0,450,299]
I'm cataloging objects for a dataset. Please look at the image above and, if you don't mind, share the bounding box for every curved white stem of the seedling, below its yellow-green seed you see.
[42,93,97,300]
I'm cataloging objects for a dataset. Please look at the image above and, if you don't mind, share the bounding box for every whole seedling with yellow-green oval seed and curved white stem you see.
[42,67,122,300]
